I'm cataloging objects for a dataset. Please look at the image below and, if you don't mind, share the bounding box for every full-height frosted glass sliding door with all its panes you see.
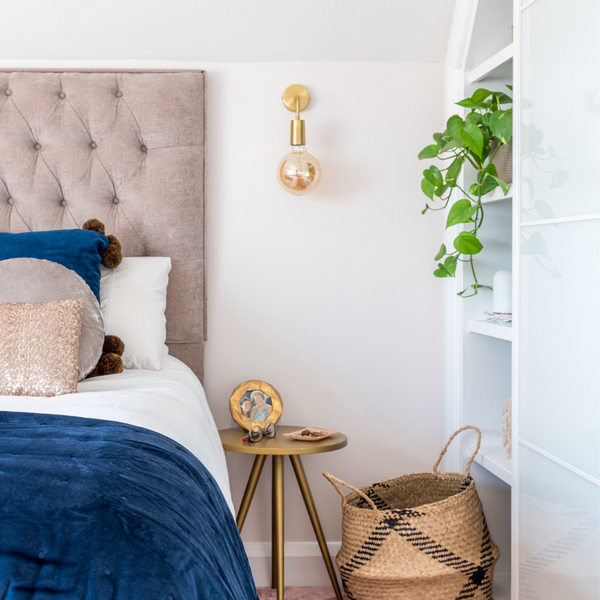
[516,0,600,600]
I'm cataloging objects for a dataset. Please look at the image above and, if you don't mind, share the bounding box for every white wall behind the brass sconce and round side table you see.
[205,62,443,585]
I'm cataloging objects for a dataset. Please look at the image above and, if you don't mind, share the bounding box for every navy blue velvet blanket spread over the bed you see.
[0,412,258,600]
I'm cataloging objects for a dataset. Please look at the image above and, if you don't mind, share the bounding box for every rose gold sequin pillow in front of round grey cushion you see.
[0,299,84,396]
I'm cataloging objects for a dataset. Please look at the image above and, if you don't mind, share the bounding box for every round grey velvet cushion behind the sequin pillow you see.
[0,258,104,381]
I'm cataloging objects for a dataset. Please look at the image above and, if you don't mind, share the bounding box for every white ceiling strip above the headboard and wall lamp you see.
[0,0,455,62]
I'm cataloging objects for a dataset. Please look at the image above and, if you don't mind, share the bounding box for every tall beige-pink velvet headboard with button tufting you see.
[0,70,206,379]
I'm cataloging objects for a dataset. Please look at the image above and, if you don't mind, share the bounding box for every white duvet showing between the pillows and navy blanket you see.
[0,356,233,512]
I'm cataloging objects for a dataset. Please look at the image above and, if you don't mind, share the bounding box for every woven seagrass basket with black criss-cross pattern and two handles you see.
[323,426,499,600]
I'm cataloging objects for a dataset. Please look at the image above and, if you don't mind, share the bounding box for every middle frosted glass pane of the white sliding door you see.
[519,220,600,478]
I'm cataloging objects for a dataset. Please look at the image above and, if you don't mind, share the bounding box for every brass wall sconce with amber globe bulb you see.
[277,85,321,196]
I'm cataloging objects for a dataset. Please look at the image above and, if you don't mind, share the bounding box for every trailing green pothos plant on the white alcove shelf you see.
[419,86,512,298]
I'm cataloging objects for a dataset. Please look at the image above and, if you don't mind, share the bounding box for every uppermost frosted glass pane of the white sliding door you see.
[521,0,600,221]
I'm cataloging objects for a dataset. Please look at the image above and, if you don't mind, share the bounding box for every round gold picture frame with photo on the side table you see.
[229,379,283,430]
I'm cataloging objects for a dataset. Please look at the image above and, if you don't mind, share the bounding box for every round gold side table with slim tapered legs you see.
[219,426,348,600]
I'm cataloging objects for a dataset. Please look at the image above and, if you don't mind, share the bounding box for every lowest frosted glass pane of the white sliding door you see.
[519,448,600,600]
